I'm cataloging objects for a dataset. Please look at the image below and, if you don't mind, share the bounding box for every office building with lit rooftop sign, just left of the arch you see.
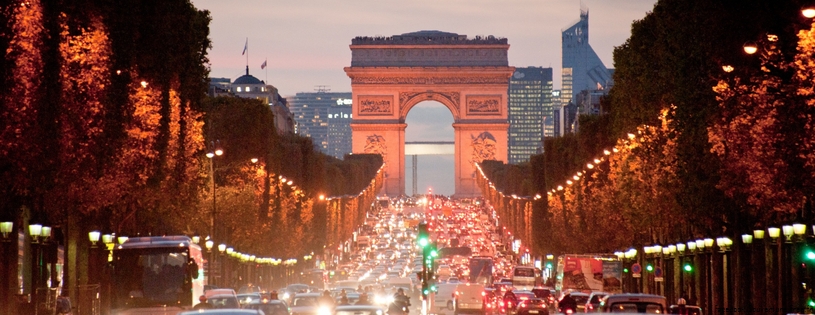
[287,91,352,159]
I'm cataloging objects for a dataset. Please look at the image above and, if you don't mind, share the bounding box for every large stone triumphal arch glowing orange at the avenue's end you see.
[345,31,515,197]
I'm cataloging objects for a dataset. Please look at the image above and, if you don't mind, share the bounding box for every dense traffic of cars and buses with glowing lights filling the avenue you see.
[112,196,701,315]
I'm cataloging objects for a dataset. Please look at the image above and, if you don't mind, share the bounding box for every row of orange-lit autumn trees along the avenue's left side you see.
[0,0,382,257]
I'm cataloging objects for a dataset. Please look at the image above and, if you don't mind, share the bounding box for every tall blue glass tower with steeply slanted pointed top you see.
[561,8,614,106]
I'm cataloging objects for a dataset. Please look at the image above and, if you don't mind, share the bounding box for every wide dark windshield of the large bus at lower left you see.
[113,247,198,308]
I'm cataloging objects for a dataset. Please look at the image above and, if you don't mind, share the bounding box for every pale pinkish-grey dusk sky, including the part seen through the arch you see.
[192,0,656,194]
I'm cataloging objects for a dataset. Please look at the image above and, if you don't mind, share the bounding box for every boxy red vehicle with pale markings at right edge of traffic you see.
[555,254,623,293]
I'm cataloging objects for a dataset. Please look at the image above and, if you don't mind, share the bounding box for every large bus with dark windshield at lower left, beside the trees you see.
[111,236,206,315]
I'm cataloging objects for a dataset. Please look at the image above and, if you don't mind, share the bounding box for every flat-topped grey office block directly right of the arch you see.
[508,67,554,164]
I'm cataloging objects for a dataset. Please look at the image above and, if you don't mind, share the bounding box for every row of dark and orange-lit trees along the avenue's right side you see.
[482,0,815,252]
